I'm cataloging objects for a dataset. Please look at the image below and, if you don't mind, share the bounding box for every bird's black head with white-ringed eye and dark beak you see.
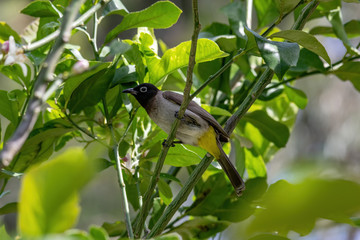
[123,83,159,109]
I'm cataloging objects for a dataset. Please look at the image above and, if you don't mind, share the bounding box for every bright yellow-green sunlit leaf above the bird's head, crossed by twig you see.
[146,39,228,83]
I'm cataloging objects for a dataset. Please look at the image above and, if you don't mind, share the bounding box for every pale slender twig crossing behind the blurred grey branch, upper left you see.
[23,0,110,52]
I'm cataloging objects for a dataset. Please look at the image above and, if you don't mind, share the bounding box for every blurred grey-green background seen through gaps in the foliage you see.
[0,0,360,240]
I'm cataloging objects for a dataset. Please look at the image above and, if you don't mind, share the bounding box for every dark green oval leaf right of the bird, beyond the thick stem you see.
[243,110,290,148]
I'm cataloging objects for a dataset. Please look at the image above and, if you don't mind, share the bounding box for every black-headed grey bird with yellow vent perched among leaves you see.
[122,83,245,196]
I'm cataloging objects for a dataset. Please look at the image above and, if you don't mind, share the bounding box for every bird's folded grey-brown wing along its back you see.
[163,91,230,142]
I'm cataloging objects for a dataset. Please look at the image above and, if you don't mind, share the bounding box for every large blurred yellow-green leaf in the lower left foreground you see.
[18,148,95,237]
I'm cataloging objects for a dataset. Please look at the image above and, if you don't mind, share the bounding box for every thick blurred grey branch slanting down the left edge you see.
[0,0,82,168]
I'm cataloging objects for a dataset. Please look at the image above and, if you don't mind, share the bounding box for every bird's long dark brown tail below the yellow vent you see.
[216,140,245,196]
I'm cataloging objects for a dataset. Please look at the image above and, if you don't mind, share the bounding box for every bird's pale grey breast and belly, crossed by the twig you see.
[148,94,209,146]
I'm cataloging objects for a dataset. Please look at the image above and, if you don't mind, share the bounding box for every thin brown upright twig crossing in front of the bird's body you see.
[135,0,201,238]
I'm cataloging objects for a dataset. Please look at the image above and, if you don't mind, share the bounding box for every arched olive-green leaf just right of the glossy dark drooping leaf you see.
[269,30,331,65]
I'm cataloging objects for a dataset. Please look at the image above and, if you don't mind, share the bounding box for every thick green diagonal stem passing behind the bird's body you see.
[148,0,317,238]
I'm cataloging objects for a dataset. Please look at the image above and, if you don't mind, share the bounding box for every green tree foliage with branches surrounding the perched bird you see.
[0,0,360,240]
